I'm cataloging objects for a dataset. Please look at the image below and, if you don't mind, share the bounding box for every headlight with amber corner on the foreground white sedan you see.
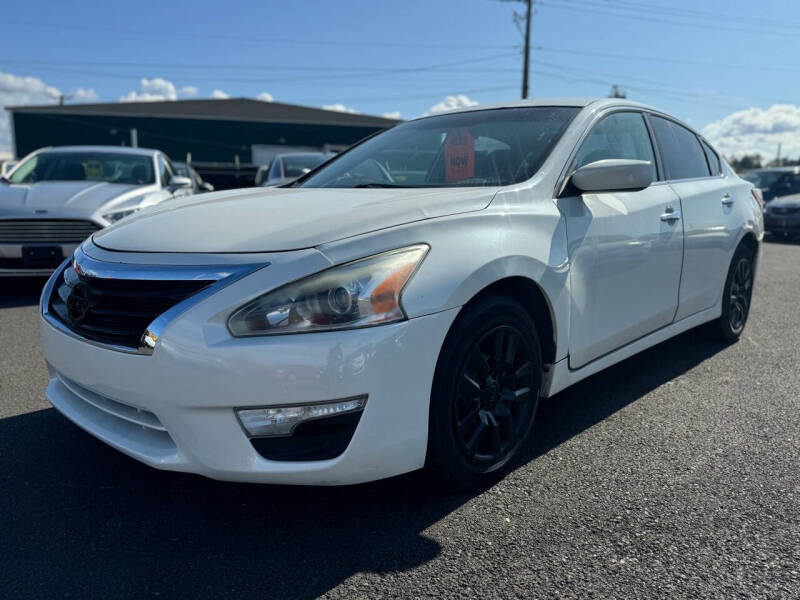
[228,244,428,337]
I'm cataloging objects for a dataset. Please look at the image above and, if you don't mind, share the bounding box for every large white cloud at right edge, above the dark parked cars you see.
[702,104,800,158]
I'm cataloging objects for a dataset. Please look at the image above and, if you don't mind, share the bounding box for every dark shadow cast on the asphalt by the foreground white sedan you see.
[0,331,724,598]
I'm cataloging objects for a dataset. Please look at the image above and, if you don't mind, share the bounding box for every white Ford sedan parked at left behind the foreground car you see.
[0,146,192,276]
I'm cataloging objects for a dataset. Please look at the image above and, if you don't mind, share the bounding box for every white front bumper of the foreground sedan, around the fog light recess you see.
[42,297,458,485]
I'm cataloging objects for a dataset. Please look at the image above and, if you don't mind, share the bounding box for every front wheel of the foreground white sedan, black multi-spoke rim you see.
[426,295,542,489]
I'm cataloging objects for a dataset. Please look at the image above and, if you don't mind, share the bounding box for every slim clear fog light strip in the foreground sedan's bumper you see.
[236,396,367,437]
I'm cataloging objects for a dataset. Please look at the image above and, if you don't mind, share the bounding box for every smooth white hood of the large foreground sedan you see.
[93,188,497,253]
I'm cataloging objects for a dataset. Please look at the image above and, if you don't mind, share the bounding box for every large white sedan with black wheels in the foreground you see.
[41,99,763,486]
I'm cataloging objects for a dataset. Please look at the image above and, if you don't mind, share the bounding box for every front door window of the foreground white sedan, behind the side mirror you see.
[575,112,658,181]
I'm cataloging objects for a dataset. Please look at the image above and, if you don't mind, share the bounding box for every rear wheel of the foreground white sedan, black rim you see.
[713,246,755,344]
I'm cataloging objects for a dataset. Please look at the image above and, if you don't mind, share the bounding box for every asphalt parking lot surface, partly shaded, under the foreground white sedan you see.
[0,243,800,598]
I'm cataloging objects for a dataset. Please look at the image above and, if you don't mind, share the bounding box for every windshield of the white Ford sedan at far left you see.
[9,152,155,185]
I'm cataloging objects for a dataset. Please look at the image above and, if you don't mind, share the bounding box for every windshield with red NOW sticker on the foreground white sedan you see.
[300,106,579,188]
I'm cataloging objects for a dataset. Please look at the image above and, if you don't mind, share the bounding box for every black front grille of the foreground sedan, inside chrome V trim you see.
[49,265,214,348]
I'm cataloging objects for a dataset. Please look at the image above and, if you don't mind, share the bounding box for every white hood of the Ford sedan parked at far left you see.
[0,181,140,216]
